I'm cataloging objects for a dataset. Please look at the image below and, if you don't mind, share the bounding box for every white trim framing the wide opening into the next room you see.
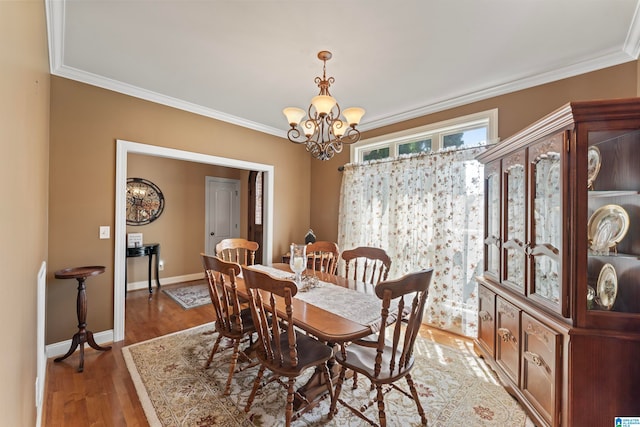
[113,139,274,341]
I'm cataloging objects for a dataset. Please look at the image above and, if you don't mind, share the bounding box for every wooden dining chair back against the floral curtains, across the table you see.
[341,246,391,285]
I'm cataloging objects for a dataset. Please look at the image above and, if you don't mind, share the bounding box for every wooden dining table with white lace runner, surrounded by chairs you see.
[236,263,397,411]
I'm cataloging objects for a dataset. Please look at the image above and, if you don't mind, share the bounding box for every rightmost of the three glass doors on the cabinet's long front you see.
[528,133,568,315]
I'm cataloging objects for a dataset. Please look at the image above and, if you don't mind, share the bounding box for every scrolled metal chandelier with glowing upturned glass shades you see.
[282,50,364,160]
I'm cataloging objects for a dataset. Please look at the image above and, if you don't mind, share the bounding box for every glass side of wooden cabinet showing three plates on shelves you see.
[579,129,640,327]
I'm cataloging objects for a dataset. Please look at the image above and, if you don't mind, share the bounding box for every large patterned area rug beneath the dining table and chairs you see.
[122,323,533,427]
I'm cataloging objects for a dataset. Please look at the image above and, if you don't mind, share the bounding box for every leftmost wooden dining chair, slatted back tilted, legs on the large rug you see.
[200,253,257,395]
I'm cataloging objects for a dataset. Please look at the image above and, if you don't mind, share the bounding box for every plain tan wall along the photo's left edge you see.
[0,1,50,426]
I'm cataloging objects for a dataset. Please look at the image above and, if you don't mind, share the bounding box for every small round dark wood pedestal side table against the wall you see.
[54,266,111,372]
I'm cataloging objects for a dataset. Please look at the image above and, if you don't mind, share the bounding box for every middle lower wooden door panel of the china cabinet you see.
[495,296,520,385]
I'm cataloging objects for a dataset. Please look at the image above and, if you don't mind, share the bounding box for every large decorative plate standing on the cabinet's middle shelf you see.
[587,205,629,251]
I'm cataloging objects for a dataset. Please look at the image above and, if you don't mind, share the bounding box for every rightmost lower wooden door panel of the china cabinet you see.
[521,313,562,425]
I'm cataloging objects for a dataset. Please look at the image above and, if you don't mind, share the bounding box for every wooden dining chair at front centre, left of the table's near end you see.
[242,268,333,426]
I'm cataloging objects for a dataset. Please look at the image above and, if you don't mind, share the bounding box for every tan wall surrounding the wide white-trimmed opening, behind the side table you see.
[47,77,311,343]
